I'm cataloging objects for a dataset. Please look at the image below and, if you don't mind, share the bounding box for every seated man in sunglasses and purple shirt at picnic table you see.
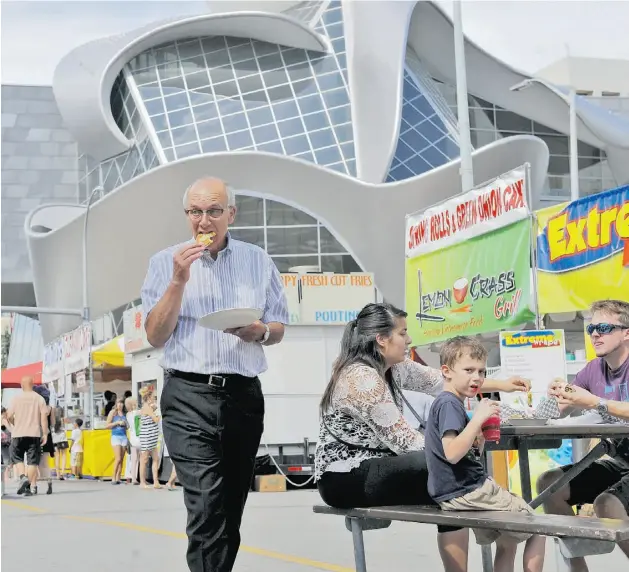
[537,300,629,572]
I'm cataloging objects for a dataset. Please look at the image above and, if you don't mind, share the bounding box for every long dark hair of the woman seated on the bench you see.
[320,303,407,415]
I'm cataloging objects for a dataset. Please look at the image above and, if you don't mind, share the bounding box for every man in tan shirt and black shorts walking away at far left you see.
[6,376,48,496]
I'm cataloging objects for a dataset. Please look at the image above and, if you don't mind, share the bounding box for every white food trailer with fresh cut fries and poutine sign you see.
[124,273,377,481]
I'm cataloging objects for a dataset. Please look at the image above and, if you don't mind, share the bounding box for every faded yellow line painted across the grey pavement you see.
[2,499,355,572]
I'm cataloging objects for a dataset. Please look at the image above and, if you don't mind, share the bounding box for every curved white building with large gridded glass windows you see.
[26,0,629,340]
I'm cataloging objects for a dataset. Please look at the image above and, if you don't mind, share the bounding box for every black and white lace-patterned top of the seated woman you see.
[315,360,443,480]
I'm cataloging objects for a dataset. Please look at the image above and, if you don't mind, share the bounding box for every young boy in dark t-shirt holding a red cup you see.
[425,336,545,572]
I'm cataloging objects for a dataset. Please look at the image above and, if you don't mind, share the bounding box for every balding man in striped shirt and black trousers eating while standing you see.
[142,177,288,572]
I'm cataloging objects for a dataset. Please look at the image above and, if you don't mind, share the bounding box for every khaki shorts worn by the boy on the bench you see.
[439,479,534,545]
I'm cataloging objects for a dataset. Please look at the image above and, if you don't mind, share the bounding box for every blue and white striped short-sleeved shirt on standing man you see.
[142,235,288,377]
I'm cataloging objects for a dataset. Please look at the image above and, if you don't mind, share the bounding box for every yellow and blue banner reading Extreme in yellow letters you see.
[536,186,629,314]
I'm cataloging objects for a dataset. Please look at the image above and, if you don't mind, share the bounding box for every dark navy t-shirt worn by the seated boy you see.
[425,391,487,502]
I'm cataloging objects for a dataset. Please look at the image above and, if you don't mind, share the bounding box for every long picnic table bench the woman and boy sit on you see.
[313,505,629,572]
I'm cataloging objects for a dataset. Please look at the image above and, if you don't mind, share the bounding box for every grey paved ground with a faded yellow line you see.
[2,480,628,572]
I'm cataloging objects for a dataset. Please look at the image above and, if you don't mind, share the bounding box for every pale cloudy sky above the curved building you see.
[0,0,629,85]
